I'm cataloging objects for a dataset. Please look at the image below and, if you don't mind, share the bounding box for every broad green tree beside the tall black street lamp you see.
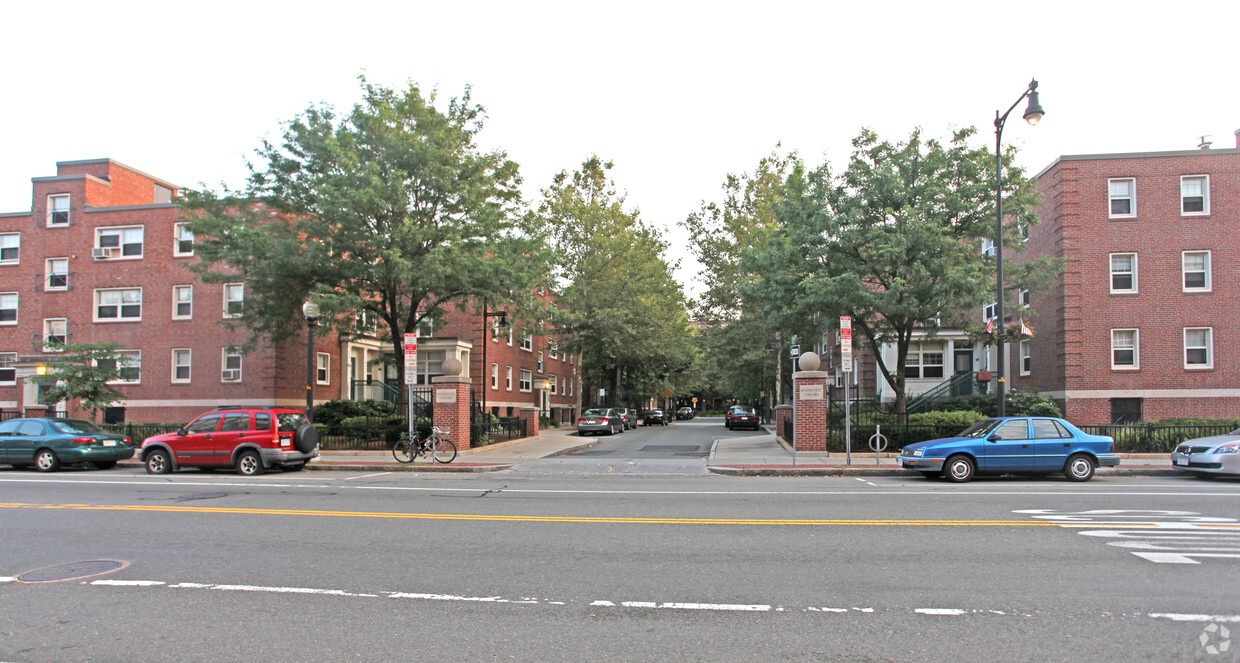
[763,129,1053,413]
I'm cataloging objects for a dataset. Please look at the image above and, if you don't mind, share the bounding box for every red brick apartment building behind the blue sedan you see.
[1007,149,1240,424]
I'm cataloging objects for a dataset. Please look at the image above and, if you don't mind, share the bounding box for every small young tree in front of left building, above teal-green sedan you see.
[38,341,126,421]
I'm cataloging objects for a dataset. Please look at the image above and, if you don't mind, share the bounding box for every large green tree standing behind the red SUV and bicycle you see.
[182,78,547,380]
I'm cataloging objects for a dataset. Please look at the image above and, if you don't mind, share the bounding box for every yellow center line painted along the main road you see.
[0,502,1240,529]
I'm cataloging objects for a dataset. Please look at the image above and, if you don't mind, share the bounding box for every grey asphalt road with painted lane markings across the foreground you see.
[0,425,1240,662]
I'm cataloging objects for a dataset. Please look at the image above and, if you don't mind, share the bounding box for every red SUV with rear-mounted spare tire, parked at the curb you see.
[140,406,319,475]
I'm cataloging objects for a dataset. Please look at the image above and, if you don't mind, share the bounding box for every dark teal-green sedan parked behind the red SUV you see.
[0,419,134,472]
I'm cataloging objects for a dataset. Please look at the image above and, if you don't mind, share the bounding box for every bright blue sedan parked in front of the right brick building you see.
[898,416,1120,482]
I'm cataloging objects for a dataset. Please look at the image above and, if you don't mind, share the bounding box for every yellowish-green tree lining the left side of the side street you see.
[541,156,693,402]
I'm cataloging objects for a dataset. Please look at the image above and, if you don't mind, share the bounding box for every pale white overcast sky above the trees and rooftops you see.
[0,0,1240,296]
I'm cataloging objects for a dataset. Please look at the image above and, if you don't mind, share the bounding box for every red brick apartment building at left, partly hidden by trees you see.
[0,159,579,423]
